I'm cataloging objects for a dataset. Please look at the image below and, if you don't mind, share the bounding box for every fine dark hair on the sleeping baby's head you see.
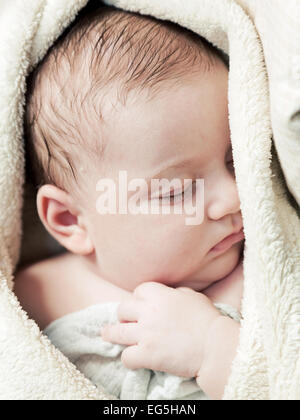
[24,0,228,189]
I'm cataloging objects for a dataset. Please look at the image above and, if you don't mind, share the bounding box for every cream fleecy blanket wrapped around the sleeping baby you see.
[0,0,300,399]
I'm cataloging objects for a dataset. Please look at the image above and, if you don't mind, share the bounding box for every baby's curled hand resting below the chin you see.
[102,282,221,377]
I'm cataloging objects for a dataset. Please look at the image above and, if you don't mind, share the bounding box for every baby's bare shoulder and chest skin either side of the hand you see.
[14,249,243,330]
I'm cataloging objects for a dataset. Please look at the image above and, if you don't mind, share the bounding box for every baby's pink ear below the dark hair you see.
[37,184,94,255]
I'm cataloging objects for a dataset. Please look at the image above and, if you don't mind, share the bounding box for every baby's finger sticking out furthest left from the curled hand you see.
[101,322,138,346]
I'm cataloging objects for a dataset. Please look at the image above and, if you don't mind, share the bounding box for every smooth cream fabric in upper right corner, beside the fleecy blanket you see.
[237,0,300,205]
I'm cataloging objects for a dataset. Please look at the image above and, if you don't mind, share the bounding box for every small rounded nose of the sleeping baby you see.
[205,175,241,220]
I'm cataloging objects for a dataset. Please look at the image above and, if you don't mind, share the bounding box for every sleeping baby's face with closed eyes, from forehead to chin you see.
[81,63,243,291]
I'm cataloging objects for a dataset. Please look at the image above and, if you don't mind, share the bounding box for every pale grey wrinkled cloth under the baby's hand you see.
[43,302,240,400]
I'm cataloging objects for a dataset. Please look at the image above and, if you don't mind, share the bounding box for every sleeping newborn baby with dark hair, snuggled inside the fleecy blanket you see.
[15,2,244,399]
